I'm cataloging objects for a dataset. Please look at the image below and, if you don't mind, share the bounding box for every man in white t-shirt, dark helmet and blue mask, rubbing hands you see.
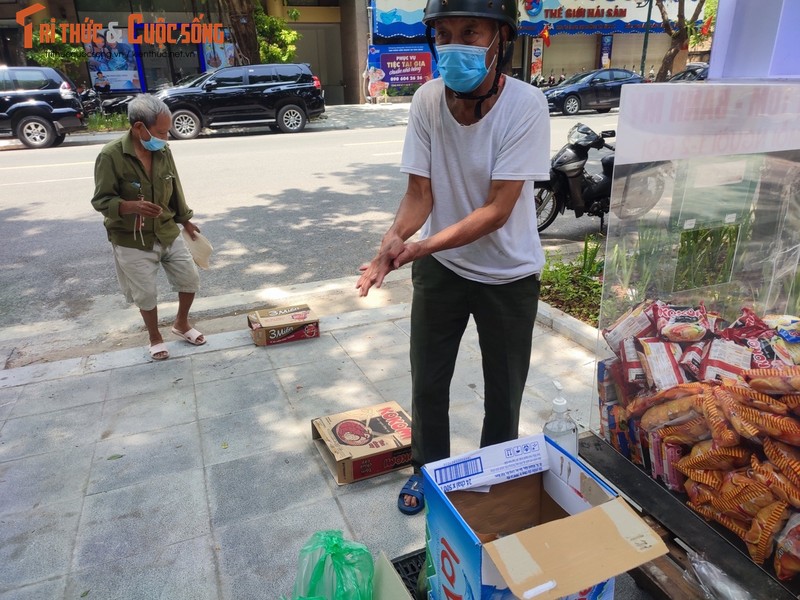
[356,0,550,514]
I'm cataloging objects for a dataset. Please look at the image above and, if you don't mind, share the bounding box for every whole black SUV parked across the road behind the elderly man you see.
[158,64,325,140]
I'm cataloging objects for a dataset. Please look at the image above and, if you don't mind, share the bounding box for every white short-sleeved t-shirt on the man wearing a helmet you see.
[400,77,550,284]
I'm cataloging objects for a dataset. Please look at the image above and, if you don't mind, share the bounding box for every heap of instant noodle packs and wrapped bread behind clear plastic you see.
[597,300,800,580]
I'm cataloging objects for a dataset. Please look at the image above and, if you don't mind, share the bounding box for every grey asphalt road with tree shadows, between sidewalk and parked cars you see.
[0,112,616,342]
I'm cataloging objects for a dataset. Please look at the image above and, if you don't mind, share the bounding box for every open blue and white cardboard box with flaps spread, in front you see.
[422,434,667,600]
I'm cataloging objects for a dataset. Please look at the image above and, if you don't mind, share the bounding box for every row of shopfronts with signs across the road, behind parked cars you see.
[0,0,697,104]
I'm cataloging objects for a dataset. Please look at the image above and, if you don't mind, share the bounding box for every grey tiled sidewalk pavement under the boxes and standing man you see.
[0,276,620,600]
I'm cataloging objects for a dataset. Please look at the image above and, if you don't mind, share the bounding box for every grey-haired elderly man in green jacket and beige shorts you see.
[92,94,206,360]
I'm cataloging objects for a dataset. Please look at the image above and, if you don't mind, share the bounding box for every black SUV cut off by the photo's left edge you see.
[0,66,86,148]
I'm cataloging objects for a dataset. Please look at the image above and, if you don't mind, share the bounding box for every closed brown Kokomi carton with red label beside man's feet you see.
[311,402,411,485]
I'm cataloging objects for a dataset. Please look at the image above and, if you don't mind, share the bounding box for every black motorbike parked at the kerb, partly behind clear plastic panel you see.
[536,123,665,232]
